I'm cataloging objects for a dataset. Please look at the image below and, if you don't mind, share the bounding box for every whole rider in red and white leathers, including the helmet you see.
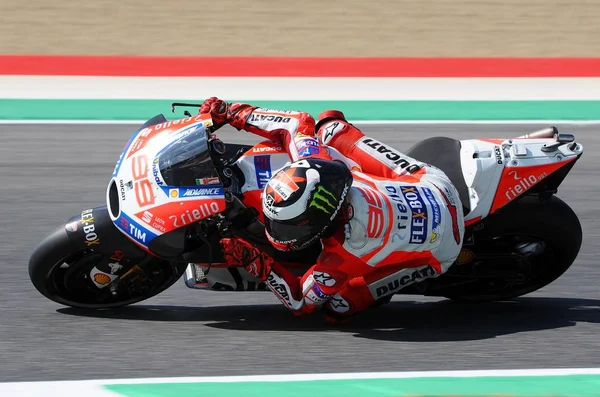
[200,97,464,321]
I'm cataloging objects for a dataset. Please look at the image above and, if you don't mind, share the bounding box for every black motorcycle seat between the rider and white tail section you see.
[405,137,471,215]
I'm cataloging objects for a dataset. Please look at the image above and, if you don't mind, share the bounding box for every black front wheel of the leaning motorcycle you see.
[29,227,187,309]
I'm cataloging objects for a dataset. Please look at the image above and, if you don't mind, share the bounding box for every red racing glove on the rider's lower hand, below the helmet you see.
[221,237,274,281]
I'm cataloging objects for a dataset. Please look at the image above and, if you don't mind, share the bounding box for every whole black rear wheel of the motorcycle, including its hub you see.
[440,196,582,302]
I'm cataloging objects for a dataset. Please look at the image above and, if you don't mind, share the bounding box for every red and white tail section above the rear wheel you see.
[461,127,583,225]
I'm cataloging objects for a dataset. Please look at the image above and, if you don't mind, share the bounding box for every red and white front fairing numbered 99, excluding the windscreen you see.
[107,115,225,248]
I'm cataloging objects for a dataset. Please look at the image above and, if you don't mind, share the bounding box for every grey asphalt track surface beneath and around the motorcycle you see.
[0,121,600,381]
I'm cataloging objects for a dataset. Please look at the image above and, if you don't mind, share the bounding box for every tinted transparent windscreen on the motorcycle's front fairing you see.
[158,125,221,186]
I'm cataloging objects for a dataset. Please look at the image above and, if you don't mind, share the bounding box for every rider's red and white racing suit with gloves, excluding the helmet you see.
[200,97,464,319]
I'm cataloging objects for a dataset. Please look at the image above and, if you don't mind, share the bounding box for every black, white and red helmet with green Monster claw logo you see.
[262,158,352,251]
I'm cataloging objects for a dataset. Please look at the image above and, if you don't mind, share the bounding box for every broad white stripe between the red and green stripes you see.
[0,76,600,101]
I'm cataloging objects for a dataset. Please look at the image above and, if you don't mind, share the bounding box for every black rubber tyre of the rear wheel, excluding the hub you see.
[443,196,582,302]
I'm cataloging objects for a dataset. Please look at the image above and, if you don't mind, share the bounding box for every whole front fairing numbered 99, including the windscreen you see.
[106,115,225,249]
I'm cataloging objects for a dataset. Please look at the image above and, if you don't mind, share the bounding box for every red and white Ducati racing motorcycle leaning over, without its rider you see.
[29,104,583,308]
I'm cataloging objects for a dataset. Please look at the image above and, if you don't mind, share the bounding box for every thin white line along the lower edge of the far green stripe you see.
[0,118,600,125]
